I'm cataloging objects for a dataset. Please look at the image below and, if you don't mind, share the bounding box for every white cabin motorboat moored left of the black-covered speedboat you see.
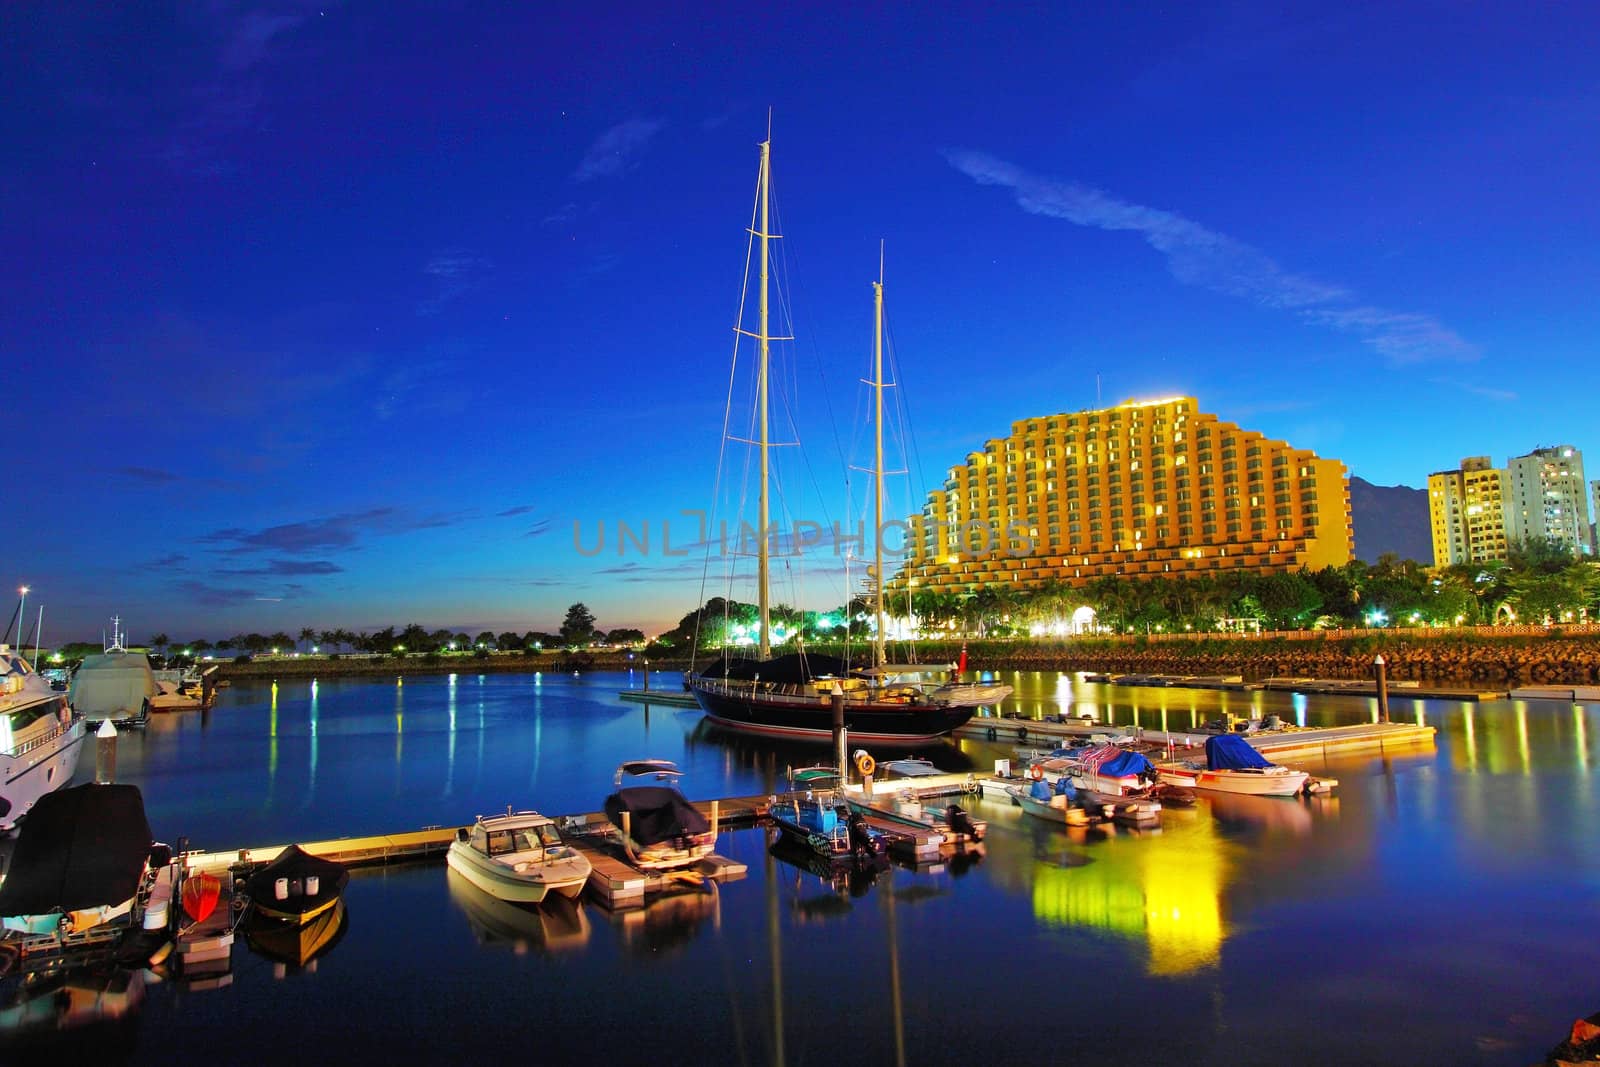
[445,806,590,904]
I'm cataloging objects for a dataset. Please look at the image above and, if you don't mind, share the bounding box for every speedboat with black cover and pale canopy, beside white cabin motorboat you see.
[605,760,717,870]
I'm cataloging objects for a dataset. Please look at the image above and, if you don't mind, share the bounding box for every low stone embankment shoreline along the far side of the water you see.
[218,630,1600,685]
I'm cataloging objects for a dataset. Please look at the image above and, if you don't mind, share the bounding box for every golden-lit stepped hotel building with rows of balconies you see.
[890,397,1354,593]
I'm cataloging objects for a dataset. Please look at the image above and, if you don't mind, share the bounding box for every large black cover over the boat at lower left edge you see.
[0,784,155,915]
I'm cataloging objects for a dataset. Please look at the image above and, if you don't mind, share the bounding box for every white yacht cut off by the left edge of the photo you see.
[0,645,85,832]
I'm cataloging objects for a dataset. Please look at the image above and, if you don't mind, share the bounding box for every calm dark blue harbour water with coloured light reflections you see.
[12,673,1600,1064]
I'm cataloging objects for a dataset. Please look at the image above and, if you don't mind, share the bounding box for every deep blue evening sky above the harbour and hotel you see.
[0,2,1600,638]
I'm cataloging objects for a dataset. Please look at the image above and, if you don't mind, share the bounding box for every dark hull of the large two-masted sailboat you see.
[693,685,978,745]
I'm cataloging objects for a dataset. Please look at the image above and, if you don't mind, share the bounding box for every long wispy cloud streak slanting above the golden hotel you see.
[946,152,1480,363]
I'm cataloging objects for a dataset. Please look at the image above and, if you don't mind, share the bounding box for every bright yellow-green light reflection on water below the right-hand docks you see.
[1034,819,1229,974]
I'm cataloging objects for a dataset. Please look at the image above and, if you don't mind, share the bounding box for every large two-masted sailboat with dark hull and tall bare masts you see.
[690,139,1011,745]
